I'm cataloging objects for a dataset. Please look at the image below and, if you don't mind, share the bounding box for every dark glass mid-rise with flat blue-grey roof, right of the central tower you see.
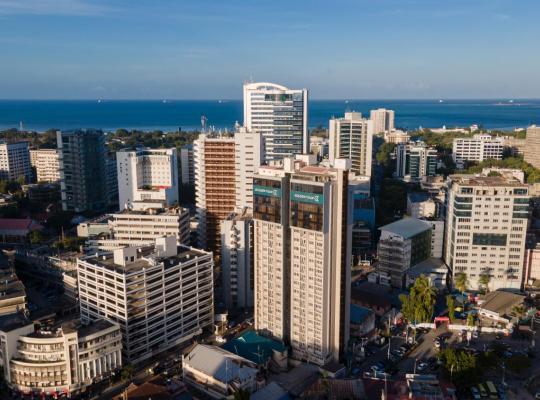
[377,218,432,288]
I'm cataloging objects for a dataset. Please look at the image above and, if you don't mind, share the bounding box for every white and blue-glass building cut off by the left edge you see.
[0,142,32,183]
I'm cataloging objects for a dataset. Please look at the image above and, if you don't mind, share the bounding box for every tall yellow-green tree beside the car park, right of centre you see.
[399,275,437,323]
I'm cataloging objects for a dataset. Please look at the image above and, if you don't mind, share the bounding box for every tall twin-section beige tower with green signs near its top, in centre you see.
[253,156,351,365]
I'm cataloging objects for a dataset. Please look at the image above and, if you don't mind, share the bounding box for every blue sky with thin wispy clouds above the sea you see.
[0,0,540,99]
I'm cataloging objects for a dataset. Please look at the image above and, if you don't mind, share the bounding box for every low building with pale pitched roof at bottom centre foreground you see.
[182,344,258,399]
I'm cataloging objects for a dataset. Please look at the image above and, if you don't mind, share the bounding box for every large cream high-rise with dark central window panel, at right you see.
[445,175,529,290]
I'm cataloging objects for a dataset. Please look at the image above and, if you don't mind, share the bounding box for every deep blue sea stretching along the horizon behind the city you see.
[0,99,540,131]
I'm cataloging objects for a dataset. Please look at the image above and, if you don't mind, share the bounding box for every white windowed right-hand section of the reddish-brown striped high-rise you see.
[234,127,264,211]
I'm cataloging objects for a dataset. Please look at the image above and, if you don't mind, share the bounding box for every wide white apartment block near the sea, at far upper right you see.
[452,135,504,167]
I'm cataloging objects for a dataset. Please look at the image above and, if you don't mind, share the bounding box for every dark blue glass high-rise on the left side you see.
[56,129,108,212]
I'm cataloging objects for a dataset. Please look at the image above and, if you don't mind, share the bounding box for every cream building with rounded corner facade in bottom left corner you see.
[0,319,122,397]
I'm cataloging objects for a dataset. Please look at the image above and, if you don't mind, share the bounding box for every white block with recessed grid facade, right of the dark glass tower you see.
[116,148,178,210]
